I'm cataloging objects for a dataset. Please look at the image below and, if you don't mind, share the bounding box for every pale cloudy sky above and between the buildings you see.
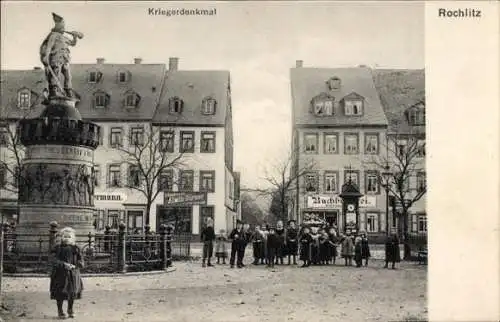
[1,1,424,187]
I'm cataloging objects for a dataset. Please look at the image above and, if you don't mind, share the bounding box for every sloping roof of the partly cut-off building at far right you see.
[373,69,425,133]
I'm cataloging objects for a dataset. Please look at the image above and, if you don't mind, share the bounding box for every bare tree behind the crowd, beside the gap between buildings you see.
[249,148,315,220]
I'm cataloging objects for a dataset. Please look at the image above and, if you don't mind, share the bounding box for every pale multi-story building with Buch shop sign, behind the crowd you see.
[291,61,426,240]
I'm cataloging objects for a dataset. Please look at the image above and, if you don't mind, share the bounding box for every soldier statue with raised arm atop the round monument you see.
[40,13,83,99]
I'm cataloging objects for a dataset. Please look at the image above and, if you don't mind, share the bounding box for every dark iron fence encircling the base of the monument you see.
[0,223,191,274]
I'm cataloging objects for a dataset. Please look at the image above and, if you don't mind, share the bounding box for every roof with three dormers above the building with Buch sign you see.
[290,67,387,126]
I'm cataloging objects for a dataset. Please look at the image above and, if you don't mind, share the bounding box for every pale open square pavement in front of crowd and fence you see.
[0,258,427,322]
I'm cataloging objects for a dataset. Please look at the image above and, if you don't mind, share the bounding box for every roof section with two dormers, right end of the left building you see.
[153,70,230,126]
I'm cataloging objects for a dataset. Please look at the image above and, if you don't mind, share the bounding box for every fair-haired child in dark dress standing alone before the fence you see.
[50,227,83,319]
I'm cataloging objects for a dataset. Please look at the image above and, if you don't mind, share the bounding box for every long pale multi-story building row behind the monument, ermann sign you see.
[2,58,236,234]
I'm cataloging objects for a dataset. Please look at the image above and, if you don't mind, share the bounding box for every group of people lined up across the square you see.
[201,219,400,269]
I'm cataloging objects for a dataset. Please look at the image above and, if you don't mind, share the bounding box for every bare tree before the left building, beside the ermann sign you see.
[117,124,186,226]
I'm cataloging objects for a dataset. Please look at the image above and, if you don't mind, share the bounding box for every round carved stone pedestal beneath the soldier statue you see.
[16,99,100,251]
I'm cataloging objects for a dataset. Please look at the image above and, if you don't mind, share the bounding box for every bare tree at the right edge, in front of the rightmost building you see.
[368,126,427,259]
